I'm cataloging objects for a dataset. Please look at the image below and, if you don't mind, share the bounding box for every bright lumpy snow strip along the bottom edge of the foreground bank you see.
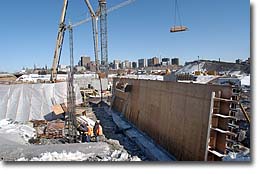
[17,151,94,161]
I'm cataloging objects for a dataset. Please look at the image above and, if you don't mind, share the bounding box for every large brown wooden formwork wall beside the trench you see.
[112,78,232,161]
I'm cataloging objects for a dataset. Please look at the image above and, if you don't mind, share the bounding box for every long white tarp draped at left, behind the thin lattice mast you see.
[0,82,82,121]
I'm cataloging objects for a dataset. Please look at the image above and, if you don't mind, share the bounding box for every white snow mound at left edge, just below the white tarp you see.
[0,118,36,144]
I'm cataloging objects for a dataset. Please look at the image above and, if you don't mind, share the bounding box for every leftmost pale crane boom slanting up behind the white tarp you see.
[50,0,68,82]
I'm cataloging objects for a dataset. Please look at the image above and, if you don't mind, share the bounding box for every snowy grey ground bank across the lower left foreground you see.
[0,119,141,161]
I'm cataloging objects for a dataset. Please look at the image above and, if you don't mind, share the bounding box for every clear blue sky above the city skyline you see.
[0,0,250,72]
